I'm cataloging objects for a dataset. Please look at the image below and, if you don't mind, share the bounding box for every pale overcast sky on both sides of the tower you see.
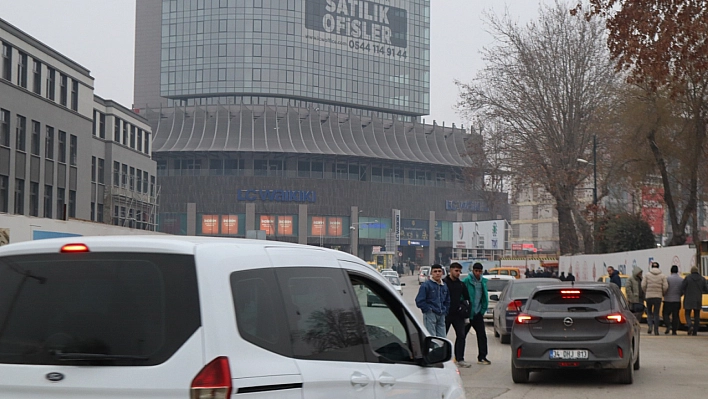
[0,0,553,126]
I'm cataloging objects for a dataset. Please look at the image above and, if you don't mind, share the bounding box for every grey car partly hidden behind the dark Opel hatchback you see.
[491,277,561,344]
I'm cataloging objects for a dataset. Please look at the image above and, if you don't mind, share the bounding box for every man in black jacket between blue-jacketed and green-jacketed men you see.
[443,262,472,368]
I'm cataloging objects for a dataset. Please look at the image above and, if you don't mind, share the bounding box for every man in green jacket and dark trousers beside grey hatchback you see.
[463,262,492,365]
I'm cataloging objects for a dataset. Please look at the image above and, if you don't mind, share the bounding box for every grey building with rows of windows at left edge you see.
[0,20,156,228]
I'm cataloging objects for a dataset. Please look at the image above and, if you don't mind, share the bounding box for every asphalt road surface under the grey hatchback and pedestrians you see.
[401,276,708,399]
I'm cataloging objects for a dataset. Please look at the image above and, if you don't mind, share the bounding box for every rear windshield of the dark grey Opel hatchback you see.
[527,289,612,312]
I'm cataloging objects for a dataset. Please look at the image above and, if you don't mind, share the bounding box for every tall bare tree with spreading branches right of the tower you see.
[457,2,617,253]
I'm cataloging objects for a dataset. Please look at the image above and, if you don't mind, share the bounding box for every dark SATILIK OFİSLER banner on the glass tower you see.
[303,0,408,60]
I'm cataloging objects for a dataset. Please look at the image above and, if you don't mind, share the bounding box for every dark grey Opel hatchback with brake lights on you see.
[511,282,640,384]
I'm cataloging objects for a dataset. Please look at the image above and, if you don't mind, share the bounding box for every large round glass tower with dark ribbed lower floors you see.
[134,0,508,264]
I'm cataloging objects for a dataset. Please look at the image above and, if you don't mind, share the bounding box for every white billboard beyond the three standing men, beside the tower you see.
[452,219,506,249]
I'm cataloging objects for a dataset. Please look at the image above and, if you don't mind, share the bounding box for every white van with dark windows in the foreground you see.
[0,236,464,399]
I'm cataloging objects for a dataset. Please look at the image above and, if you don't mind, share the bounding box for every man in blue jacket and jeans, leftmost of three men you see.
[415,263,450,338]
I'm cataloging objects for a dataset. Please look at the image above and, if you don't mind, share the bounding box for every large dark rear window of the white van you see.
[0,253,201,366]
